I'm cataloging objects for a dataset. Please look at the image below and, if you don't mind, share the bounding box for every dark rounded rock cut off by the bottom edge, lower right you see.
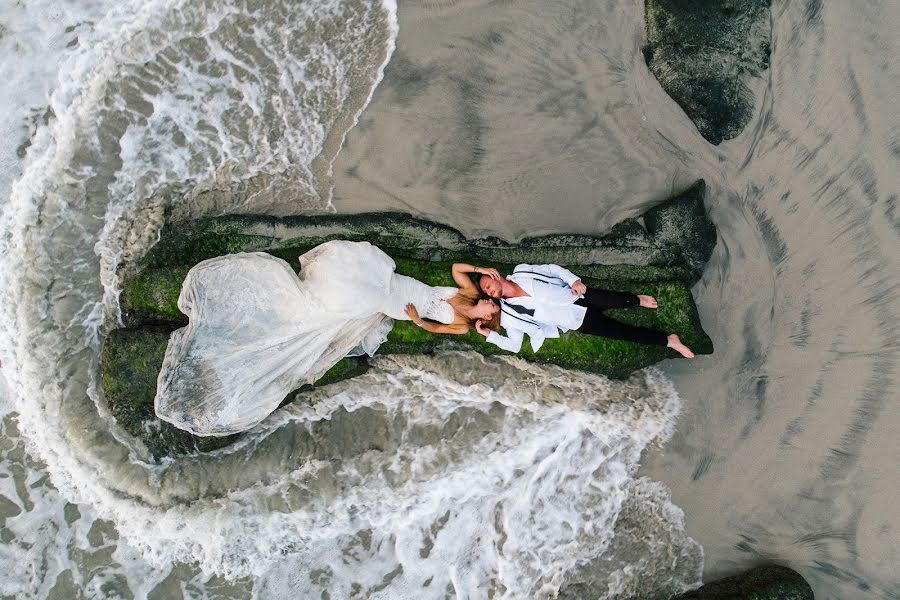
[672,565,813,600]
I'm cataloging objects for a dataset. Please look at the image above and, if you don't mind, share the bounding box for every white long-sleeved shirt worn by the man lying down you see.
[487,264,586,352]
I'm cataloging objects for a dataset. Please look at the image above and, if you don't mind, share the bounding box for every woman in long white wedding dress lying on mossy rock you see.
[154,240,500,436]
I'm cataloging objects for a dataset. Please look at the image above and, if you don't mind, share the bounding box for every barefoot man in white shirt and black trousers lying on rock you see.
[475,264,694,358]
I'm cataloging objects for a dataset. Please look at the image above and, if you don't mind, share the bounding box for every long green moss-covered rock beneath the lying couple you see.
[100,181,716,456]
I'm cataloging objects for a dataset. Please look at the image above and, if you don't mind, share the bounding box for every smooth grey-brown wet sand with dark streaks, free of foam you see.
[334,1,900,598]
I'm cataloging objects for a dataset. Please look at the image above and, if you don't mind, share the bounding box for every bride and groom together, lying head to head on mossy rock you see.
[154,240,693,435]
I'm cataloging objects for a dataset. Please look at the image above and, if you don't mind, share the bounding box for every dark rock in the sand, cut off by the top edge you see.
[644,0,771,144]
